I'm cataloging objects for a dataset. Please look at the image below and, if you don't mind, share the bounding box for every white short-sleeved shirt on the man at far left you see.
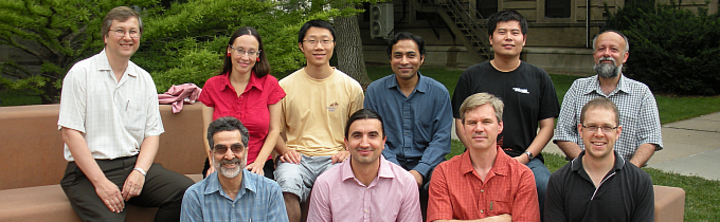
[58,50,164,161]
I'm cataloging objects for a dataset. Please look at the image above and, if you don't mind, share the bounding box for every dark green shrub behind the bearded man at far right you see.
[606,1,720,95]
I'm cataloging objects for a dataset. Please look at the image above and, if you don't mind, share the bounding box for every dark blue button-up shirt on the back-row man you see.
[364,72,453,179]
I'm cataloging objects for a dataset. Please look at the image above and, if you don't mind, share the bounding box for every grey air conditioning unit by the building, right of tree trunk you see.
[370,2,395,38]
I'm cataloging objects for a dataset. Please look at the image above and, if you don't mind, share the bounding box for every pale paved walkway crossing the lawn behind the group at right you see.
[453,112,720,180]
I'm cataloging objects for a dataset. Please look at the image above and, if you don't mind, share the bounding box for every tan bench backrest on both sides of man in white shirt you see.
[0,103,207,190]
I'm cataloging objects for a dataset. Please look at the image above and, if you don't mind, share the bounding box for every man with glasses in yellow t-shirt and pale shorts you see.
[275,20,364,221]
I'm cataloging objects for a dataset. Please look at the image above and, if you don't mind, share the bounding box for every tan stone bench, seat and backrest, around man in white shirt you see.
[0,104,207,221]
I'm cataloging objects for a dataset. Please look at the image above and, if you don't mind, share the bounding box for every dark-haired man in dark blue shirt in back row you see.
[363,32,453,196]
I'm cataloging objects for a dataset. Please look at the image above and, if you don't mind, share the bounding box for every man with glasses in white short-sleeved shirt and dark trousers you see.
[57,6,193,221]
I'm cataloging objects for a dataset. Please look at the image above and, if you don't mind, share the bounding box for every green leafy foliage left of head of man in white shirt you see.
[0,0,157,103]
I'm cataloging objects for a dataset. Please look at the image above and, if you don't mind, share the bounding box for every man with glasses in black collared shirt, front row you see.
[544,97,655,222]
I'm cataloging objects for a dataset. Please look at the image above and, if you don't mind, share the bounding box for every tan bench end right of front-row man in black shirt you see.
[653,185,685,222]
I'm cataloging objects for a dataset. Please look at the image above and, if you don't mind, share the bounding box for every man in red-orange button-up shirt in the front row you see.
[427,93,540,221]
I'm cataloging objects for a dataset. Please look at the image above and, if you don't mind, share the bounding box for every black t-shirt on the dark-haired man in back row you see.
[452,61,560,160]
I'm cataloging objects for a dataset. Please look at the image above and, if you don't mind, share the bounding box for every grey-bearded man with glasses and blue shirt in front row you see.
[180,117,288,222]
